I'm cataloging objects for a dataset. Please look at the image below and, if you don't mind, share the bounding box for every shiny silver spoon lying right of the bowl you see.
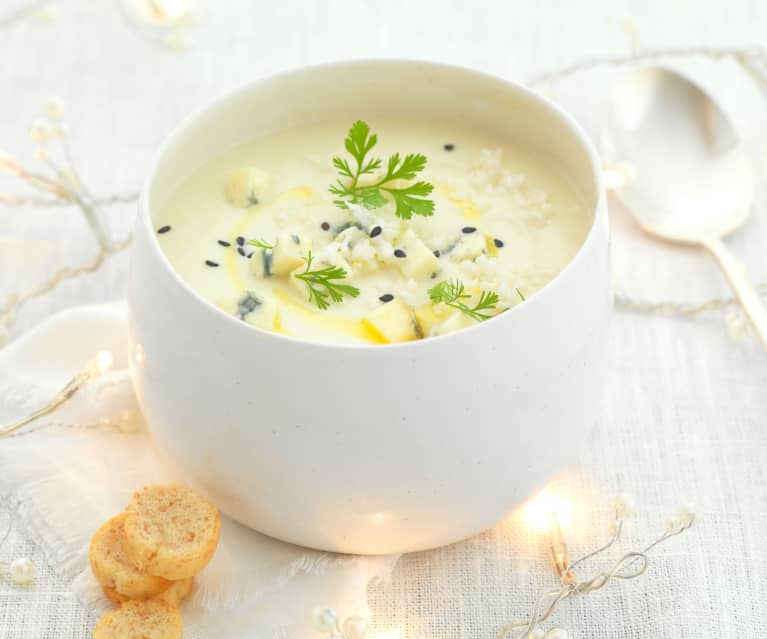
[605,68,767,349]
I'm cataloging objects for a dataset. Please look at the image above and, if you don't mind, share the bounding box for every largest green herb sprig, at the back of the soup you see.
[329,120,434,220]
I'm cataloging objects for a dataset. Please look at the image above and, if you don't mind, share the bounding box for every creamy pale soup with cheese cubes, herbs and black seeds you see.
[156,119,591,344]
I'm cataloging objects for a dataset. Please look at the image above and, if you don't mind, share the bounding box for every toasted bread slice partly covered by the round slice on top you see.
[88,513,173,599]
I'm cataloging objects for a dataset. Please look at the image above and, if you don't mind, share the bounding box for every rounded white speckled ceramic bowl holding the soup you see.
[129,61,611,554]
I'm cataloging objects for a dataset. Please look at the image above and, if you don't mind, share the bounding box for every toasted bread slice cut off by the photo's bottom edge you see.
[93,599,183,639]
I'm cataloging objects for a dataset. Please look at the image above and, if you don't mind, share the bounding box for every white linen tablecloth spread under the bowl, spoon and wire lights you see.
[0,0,767,639]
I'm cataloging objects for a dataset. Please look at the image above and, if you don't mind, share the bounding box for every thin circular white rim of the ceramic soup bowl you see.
[134,58,607,352]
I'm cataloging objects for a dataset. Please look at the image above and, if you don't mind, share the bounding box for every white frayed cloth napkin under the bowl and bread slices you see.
[0,305,397,638]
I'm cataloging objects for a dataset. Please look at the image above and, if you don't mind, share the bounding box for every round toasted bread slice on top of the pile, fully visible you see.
[125,484,221,580]
